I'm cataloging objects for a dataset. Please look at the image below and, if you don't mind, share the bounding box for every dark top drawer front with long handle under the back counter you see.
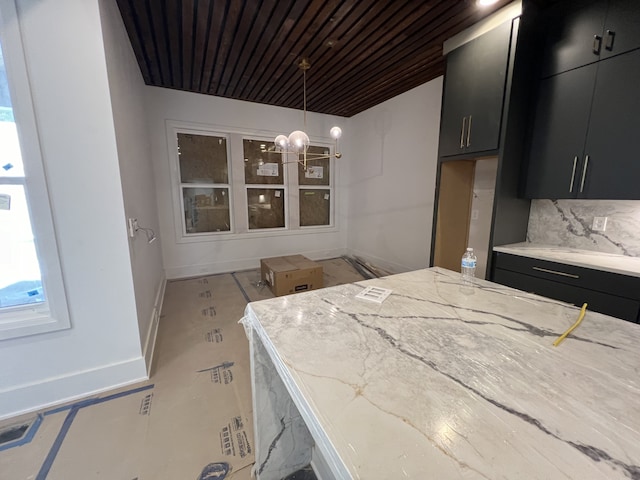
[494,252,640,301]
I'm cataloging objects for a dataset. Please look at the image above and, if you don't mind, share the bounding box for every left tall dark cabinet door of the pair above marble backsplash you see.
[525,64,597,199]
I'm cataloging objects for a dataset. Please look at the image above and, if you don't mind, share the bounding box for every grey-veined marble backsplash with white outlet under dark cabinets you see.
[527,200,640,257]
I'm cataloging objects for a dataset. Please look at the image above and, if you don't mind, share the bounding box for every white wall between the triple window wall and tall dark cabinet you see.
[345,77,442,273]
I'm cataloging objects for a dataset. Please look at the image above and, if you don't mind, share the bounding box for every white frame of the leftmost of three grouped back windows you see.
[168,124,235,241]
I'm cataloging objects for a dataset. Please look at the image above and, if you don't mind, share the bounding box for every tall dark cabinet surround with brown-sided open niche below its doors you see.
[429,7,541,277]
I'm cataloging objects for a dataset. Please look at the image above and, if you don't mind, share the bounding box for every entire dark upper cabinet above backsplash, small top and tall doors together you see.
[524,0,640,200]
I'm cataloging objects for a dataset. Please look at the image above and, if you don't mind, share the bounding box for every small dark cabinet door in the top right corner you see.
[600,0,640,59]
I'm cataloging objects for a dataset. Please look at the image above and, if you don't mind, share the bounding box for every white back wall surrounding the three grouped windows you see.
[145,87,352,278]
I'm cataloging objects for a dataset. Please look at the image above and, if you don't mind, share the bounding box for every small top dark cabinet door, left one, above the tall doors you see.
[541,0,604,78]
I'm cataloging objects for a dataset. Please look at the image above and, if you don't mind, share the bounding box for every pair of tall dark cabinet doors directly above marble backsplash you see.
[525,49,640,200]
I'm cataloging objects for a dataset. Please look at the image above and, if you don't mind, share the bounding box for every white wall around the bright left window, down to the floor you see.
[0,0,145,418]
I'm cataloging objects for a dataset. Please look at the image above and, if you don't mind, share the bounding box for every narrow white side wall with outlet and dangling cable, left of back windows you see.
[100,0,165,367]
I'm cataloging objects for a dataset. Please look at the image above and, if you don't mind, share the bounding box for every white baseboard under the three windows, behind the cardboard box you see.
[166,248,346,280]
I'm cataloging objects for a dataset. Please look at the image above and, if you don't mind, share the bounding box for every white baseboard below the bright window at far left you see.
[0,356,148,420]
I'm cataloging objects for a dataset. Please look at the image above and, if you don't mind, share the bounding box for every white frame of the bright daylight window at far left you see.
[0,0,71,340]
